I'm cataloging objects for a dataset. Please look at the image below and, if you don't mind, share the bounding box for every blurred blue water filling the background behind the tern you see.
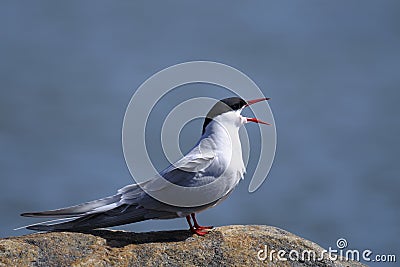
[0,1,400,266]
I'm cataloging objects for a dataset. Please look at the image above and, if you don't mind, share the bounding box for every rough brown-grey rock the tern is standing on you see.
[0,225,365,266]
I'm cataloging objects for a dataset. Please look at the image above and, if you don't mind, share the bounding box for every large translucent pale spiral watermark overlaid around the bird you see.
[122,61,276,207]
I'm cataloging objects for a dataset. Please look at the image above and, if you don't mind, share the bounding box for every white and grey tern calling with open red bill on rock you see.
[21,96,270,236]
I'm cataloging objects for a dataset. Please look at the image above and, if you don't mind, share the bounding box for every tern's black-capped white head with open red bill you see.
[202,97,270,134]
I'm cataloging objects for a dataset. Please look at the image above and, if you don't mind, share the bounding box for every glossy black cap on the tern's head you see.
[202,97,247,134]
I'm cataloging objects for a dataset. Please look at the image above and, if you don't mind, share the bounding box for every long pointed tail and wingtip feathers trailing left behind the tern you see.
[18,185,178,231]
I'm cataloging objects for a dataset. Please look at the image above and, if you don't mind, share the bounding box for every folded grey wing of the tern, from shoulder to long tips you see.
[21,140,219,231]
